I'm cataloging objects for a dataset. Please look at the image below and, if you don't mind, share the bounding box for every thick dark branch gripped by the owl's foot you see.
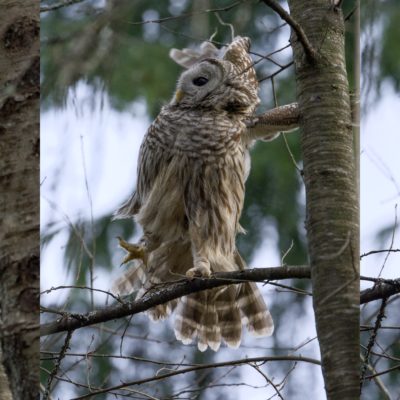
[40,266,310,336]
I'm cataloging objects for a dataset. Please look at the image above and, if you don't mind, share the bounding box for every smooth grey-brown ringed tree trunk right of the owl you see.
[289,0,360,400]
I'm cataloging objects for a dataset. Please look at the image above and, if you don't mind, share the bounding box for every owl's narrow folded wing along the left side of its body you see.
[114,118,168,219]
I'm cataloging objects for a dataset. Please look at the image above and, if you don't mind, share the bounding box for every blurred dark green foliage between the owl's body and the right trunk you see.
[239,133,306,266]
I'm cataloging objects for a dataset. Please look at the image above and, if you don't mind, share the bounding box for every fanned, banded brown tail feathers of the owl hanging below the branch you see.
[174,282,274,351]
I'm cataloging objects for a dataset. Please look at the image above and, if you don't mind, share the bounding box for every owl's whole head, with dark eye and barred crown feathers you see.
[171,37,260,115]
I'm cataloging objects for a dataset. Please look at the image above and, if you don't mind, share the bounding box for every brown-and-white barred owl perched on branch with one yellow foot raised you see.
[115,37,273,351]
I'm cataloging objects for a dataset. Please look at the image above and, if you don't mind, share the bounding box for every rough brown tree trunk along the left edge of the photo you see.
[0,0,39,400]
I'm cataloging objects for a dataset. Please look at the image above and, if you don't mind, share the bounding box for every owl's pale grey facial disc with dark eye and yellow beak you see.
[172,59,225,106]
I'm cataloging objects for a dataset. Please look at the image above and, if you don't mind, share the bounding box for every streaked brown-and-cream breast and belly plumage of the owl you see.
[137,107,245,254]
